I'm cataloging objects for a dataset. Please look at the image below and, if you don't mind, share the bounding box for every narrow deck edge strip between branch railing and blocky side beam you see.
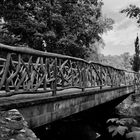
[0,86,126,110]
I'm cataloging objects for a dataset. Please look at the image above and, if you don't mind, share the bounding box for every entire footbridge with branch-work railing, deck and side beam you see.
[0,44,140,128]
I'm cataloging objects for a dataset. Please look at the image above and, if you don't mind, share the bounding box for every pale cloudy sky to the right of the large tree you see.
[101,0,140,55]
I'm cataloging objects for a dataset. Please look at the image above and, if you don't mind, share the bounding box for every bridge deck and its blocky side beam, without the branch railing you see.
[0,85,135,128]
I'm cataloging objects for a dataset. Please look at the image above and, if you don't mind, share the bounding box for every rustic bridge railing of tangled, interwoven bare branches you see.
[0,44,140,95]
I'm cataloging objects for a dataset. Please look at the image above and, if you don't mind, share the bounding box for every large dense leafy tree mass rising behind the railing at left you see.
[0,0,113,58]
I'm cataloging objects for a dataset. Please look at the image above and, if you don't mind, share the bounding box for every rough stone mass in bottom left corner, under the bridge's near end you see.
[0,109,39,140]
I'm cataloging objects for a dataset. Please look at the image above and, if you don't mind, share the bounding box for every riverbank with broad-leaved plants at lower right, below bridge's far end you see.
[104,95,140,140]
